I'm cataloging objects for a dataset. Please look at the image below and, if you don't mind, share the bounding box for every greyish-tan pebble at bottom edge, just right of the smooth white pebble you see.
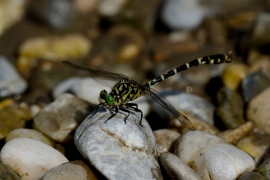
[41,161,97,180]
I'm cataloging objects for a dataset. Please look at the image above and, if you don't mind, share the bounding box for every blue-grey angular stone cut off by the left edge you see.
[0,56,27,98]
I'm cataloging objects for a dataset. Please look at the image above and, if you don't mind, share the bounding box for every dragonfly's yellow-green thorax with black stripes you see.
[110,79,146,105]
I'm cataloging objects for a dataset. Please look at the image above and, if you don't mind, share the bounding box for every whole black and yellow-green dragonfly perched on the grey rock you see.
[62,51,233,130]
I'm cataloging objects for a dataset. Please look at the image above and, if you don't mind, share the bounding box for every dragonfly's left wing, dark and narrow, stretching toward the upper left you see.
[62,61,128,81]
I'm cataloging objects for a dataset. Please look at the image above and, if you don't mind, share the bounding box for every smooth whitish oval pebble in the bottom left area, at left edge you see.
[0,138,68,180]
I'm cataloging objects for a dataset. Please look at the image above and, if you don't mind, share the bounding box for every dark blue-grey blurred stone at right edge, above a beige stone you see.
[242,72,270,102]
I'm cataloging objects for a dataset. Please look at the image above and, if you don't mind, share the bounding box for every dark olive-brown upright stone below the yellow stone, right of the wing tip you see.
[217,87,245,129]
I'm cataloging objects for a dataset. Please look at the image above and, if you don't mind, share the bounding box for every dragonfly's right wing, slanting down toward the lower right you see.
[147,89,195,130]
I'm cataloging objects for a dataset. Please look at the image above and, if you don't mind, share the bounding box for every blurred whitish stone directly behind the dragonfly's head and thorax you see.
[53,77,150,116]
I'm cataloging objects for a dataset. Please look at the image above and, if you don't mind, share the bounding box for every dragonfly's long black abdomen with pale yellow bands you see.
[144,52,233,88]
